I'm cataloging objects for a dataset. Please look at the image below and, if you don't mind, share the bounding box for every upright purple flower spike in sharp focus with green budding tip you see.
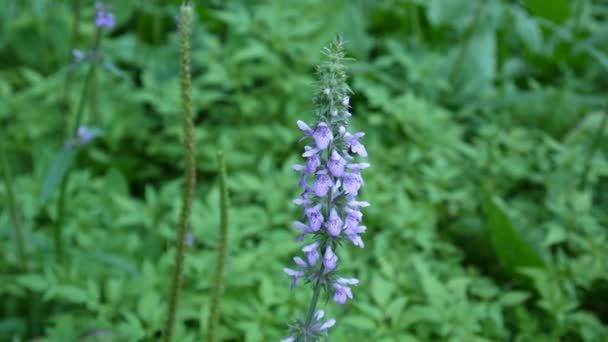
[284,39,370,341]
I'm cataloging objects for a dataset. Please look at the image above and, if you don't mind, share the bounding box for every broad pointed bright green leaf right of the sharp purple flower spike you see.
[483,191,545,277]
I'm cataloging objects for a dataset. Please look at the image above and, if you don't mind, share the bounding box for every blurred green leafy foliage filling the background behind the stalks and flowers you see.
[0,0,608,341]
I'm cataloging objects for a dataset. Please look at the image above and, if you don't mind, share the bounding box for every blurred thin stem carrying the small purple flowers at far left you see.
[53,29,101,262]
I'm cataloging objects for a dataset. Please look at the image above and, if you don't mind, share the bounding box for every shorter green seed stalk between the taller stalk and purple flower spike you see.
[207,152,230,342]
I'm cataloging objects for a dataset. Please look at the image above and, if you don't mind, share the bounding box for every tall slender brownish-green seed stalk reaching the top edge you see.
[163,4,196,342]
